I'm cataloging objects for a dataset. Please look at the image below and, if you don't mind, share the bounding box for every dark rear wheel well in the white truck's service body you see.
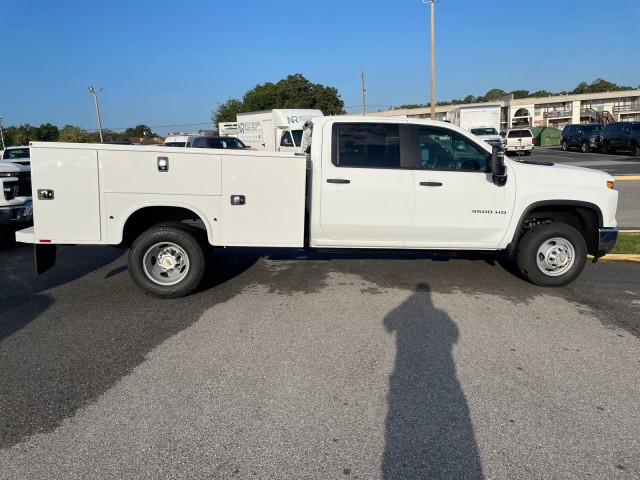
[119,207,207,247]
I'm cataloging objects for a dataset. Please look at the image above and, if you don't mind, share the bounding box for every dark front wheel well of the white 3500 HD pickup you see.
[513,205,601,255]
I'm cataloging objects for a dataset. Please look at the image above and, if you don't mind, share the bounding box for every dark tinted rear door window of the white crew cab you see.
[332,123,401,168]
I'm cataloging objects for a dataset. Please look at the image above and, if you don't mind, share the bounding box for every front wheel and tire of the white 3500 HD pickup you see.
[516,223,587,287]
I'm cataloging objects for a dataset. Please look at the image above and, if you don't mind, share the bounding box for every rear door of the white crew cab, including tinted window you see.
[320,122,414,247]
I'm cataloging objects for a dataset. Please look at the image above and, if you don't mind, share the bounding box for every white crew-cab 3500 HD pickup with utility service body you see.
[16,117,618,298]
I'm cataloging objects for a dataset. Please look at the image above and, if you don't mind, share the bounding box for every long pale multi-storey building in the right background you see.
[367,90,640,129]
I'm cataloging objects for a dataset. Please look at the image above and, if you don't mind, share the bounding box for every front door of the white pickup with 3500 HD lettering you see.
[406,126,515,249]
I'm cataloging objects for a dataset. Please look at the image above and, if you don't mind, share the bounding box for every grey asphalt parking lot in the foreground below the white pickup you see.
[0,239,640,479]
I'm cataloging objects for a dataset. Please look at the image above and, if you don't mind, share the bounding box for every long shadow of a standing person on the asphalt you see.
[382,284,484,480]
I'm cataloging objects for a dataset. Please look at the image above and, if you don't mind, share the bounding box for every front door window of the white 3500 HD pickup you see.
[418,127,489,172]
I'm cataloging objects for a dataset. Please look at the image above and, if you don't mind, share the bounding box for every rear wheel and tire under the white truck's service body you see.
[128,224,206,298]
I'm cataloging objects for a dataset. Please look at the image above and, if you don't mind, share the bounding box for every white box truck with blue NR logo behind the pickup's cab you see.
[237,108,324,152]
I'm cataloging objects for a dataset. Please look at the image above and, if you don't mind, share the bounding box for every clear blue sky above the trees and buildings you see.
[0,0,640,135]
